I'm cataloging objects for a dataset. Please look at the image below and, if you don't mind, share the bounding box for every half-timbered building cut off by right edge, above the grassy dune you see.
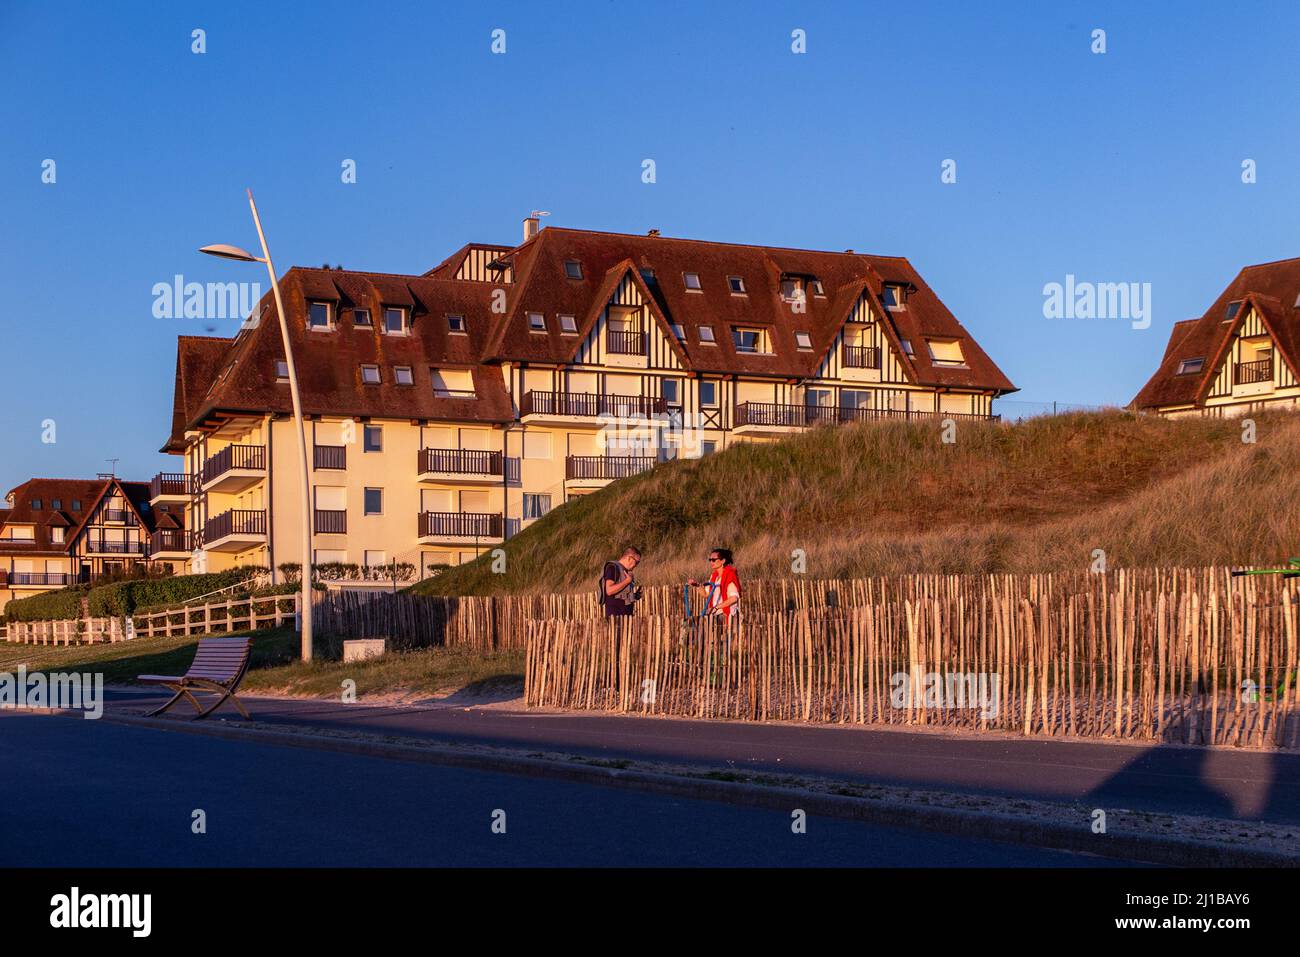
[1131,259,1300,416]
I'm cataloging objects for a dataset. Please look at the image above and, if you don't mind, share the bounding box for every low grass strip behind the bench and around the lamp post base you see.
[0,628,524,700]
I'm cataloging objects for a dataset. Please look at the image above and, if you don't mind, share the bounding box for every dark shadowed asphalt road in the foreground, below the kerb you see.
[0,713,1138,867]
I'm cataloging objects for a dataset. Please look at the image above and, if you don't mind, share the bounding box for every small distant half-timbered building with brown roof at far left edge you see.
[0,476,190,611]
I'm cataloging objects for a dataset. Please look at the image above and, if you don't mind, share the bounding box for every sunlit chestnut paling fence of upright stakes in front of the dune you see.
[525,570,1300,748]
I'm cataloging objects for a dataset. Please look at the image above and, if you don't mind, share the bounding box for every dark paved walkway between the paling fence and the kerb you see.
[107,689,1300,824]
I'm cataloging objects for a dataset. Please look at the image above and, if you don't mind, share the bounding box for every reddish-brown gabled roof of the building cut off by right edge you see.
[1130,259,1300,408]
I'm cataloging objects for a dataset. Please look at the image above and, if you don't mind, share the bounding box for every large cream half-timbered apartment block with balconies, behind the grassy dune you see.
[152,218,1014,576]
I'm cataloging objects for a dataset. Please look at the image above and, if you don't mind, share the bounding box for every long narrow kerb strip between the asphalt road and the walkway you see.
[89,713,1300,867]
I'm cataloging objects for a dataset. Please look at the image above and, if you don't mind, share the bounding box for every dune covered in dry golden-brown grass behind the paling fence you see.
[417,411,1300,594]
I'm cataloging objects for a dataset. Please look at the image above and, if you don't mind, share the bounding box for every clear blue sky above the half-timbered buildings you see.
[0,0,1300,489]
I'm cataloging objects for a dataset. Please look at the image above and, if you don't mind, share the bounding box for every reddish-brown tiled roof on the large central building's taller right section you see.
[484,226,1015,393]
